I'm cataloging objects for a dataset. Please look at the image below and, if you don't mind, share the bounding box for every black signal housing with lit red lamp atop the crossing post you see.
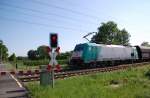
[50,33,58,48]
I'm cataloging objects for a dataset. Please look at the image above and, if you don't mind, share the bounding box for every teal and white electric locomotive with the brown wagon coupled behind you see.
[70,43,150,66]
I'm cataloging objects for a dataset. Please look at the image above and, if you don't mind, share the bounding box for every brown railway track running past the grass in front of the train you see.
[17,62,150,82]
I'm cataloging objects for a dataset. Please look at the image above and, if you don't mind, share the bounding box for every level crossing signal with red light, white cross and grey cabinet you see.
[40,33,60,88]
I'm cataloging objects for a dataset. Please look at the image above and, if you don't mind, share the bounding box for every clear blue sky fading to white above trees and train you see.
[0,0,150,56]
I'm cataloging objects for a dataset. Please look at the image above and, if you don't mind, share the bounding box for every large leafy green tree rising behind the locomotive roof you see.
[91,21,130,45]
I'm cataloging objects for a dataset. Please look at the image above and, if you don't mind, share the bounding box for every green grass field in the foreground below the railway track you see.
[26,65,150,98]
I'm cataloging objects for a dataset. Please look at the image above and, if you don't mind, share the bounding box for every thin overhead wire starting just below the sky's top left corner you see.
[1,2,97,25]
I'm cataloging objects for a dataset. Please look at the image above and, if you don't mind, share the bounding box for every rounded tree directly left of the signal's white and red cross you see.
[37,45,49,59]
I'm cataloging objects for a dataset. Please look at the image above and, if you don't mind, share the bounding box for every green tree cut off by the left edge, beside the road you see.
[0,40,8,60]
